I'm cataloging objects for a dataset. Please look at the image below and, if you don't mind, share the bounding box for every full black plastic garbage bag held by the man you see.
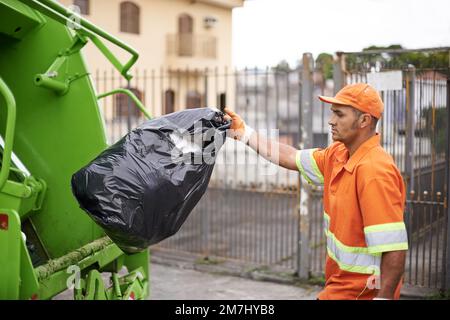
[72,108,230,253]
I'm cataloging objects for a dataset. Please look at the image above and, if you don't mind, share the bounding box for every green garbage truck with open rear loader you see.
[0,0,150,300]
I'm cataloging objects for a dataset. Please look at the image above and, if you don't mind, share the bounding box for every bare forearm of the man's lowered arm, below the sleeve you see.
[377,251,406,299]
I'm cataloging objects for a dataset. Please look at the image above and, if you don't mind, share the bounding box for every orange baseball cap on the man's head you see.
[319,83,384,119]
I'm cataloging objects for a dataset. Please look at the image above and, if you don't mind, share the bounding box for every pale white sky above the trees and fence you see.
[233,0,450,67]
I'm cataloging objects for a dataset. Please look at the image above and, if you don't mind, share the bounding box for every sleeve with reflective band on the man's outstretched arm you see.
[295,149,326,186]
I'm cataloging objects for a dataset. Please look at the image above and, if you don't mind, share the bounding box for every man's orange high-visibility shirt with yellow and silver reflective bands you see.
[296,134,408,299]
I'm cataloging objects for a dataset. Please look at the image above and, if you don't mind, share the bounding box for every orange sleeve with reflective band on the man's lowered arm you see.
[359,176,408,253]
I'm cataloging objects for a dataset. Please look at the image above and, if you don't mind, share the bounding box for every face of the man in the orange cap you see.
[328,104,359,143]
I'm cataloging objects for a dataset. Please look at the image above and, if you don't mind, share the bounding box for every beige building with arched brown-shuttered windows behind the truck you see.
[60,0,244,126]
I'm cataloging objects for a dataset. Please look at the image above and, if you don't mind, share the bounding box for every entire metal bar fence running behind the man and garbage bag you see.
[94,49,449,289]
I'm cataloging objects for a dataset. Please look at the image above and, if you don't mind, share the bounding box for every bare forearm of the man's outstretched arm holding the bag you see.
[247,132,297,170]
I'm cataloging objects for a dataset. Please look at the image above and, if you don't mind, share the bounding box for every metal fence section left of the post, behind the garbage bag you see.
[95,68,306,272]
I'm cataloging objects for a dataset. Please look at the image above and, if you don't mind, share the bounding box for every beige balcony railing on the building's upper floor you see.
[167,34,217,59]
